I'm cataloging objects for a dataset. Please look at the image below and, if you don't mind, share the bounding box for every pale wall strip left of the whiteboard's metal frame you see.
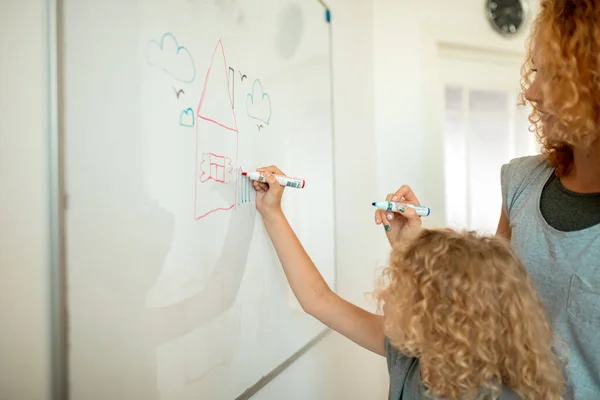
[0,0,50,400]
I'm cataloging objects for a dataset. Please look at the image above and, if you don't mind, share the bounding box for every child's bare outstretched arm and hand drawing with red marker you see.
[254,167,385,356]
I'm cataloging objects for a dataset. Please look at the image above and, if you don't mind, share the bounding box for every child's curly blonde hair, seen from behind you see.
[374,229,564,400]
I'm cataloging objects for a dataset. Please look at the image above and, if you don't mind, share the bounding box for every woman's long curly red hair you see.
[520,0,600,176]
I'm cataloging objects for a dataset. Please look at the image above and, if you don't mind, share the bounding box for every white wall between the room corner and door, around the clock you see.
[373,0,537,239]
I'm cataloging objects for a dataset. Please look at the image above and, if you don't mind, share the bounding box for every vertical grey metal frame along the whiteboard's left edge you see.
[46,0,69,400]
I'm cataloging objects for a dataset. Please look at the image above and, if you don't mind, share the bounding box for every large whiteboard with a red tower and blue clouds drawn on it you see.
[60,0,335,400]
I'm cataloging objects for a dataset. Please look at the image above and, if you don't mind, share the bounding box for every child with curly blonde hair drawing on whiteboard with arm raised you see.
[254,166,563,400]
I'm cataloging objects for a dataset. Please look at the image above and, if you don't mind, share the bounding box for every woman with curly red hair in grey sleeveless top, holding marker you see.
[375,0,600,400]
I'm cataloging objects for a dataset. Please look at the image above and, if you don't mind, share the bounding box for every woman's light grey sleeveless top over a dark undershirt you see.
[501,156,600,400]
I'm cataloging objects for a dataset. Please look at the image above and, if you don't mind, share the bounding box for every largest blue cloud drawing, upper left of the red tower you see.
[146,32,196,83]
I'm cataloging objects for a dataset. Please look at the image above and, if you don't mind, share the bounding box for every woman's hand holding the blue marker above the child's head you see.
[375,185,421,246]
